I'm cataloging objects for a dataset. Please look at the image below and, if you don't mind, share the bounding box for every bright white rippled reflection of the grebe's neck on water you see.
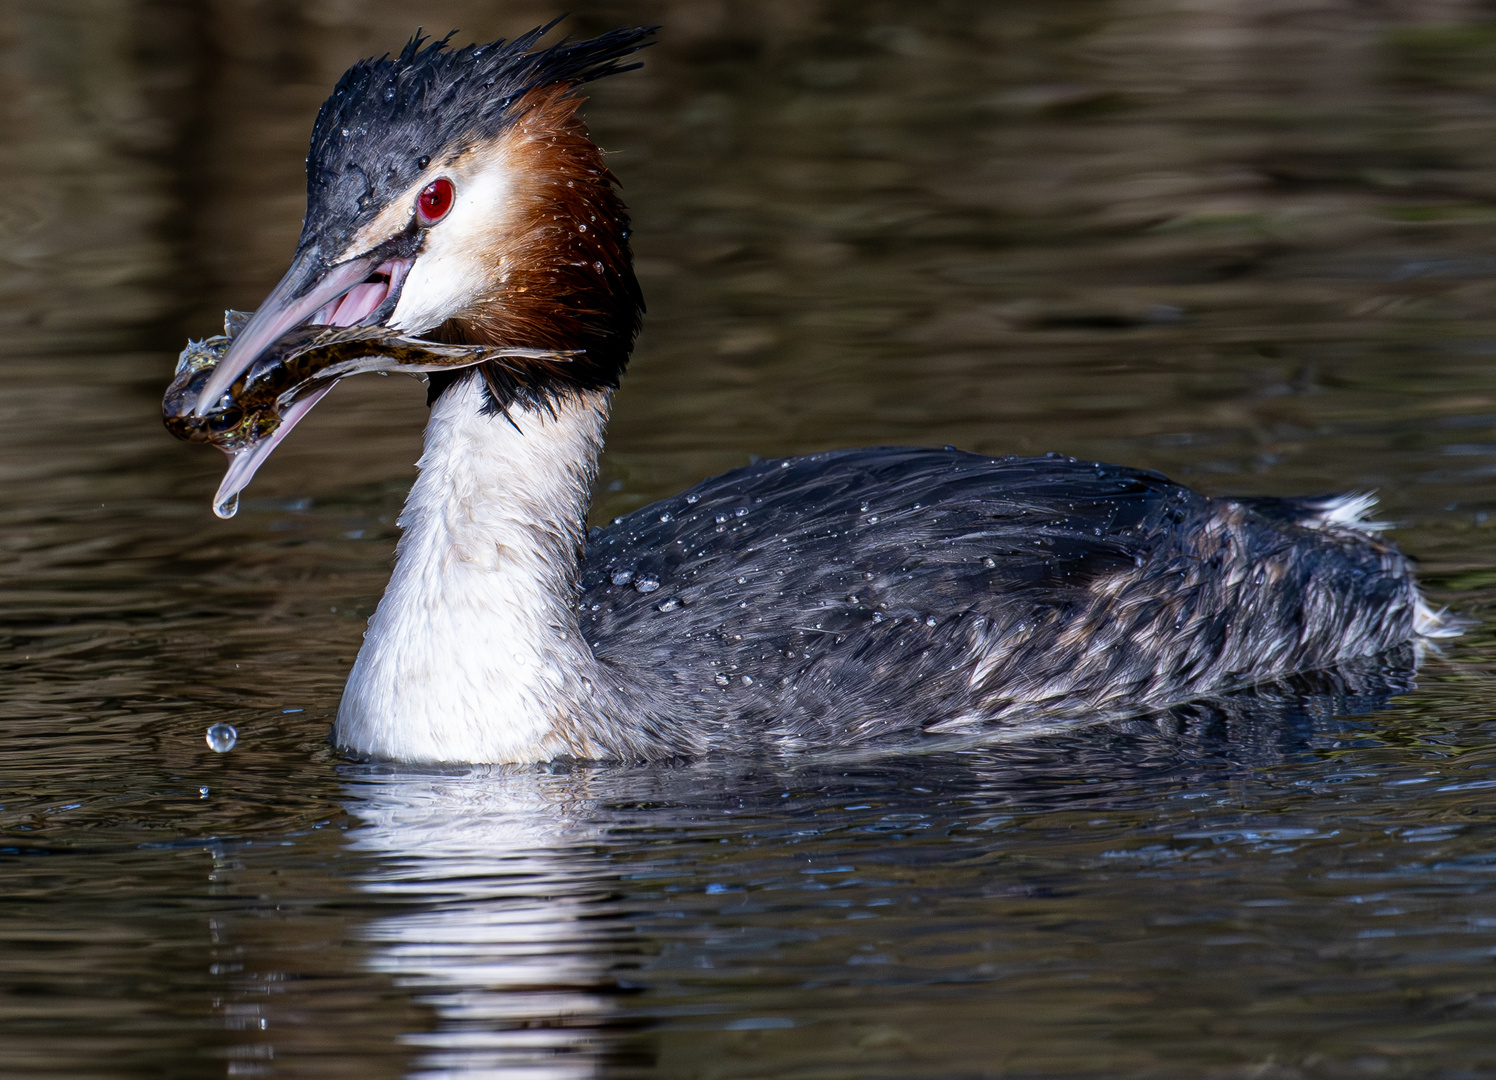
[349,769,631,1080]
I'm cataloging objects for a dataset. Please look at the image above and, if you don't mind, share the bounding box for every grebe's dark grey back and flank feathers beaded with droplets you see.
[580,447,1417,745]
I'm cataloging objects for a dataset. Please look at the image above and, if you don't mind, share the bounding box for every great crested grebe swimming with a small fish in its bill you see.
[184,27,1459,763]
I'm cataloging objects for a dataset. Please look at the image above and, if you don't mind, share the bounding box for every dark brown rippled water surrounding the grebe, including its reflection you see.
[0,0,1496,1080]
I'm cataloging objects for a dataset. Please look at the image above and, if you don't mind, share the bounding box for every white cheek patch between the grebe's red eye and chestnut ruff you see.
[389,157,515,334]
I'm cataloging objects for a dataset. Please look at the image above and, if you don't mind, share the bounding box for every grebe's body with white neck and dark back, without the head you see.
[335,378,1442,761]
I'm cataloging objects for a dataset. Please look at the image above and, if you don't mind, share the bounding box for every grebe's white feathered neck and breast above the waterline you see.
[334,377,612,763]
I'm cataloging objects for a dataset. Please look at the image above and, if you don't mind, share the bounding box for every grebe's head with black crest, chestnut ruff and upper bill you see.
[194,22,654,483]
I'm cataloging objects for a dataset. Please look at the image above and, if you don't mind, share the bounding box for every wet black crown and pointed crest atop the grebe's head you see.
[302,19,657,256]
